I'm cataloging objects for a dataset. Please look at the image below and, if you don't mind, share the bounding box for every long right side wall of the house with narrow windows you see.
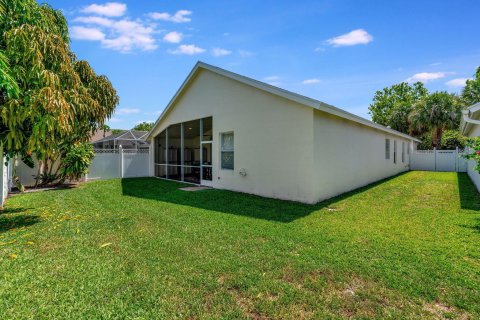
[312,110,414,201]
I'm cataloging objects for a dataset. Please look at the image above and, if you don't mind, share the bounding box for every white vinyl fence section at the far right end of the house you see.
[410,149,467,172]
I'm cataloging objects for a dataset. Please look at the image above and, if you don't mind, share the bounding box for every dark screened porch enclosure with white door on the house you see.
[154,117,212,185]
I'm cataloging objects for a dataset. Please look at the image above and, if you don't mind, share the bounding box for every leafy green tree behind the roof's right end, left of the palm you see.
[368,82,428,133]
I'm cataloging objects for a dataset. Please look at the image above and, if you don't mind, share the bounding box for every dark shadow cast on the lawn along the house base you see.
[122,175,404,223]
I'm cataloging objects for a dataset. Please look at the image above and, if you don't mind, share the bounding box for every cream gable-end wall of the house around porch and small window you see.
[152,70,316,202]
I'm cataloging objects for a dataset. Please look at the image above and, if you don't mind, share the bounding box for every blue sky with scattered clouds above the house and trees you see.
[48,0,480,129]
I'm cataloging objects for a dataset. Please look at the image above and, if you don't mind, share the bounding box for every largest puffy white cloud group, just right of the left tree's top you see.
[72,16,158,52]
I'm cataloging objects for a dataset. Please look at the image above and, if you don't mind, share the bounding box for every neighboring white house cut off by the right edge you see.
[460,102,480,191]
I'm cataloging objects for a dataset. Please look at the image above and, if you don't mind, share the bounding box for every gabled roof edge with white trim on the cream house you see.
[146,61,420,142]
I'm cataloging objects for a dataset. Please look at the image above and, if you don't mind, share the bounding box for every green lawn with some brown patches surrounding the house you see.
[0,172,480,319]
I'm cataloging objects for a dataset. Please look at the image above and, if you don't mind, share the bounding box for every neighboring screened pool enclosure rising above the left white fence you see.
[92,130,150,149]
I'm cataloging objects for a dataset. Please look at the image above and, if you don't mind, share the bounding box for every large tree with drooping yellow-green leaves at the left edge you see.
[0,0,119,180]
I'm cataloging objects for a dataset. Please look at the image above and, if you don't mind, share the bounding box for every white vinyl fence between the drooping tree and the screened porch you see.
[87,148,150,180]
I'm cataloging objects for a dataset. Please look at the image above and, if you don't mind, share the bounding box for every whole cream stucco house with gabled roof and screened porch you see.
[147,62,419,203]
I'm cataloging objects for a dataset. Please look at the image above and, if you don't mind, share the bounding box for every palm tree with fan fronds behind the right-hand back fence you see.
[409,91,461,148]
